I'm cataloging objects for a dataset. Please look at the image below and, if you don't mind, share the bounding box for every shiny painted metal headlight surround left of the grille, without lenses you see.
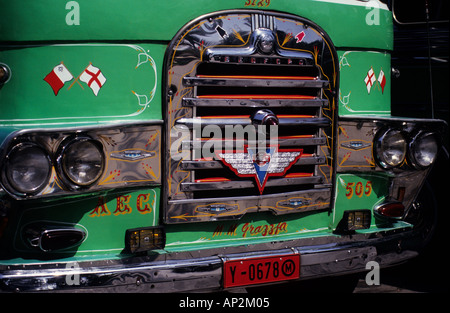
[0,120,163,201]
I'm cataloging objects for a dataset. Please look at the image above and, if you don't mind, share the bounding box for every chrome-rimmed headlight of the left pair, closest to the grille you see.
[56,136,105,189]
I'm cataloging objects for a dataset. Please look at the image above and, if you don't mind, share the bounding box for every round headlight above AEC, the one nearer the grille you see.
[58,137,104,186]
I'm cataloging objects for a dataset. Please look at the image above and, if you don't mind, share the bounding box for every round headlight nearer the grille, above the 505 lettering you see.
[375,129,407,168]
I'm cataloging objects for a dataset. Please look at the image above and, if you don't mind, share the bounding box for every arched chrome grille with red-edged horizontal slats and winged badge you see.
[164,11,337,223]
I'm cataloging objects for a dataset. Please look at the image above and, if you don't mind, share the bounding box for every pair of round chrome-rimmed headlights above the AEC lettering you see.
[2,137,105,196]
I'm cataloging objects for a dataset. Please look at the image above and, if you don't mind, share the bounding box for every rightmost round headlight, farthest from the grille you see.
[409,133,439,168]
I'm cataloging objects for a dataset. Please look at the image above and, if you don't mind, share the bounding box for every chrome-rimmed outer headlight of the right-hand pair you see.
[408,131,439,170]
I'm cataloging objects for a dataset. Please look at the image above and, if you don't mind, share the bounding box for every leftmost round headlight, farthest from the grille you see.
[5,143,52,194]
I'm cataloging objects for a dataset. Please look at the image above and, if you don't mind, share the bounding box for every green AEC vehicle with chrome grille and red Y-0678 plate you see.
[0,0,447,292]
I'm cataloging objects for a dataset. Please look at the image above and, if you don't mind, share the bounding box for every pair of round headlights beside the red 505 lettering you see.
[374,129,439,169]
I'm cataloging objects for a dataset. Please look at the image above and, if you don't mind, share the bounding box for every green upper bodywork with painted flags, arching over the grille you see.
[0,0,392,127]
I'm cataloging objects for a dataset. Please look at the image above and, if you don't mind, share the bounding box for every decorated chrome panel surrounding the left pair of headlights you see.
[0,120,162,200]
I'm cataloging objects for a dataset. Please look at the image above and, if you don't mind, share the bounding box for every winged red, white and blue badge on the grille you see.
[217,146,303,194]
